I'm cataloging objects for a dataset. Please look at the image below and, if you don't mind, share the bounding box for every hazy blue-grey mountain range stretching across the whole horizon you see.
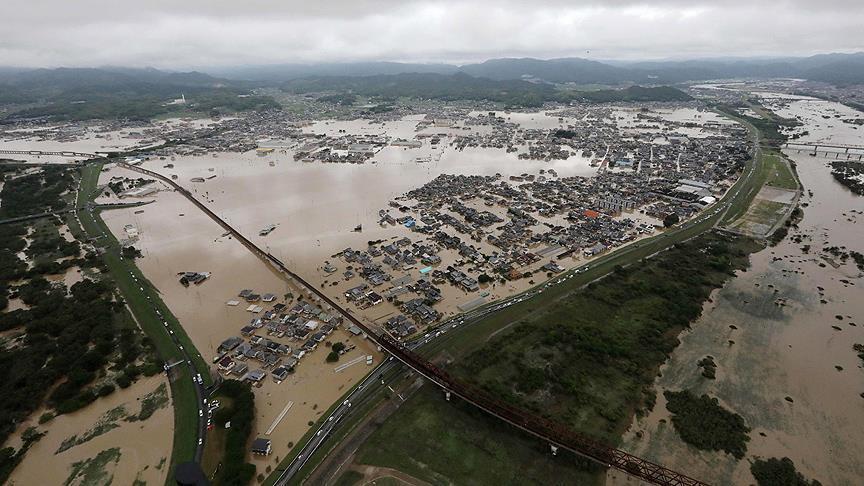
[0,52,864,98]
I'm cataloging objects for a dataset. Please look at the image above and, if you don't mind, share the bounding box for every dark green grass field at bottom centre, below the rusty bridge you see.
[357,385,602,485]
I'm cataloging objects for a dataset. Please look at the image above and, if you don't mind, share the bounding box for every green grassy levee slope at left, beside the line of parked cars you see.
[70,163,210,483]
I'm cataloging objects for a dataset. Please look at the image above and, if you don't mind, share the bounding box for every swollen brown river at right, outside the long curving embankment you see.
[610,96,864,485]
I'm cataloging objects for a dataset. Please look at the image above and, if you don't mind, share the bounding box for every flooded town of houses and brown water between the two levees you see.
[84,100,747,472]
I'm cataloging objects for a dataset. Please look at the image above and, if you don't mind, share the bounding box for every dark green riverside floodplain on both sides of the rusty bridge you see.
[346,234,755,484]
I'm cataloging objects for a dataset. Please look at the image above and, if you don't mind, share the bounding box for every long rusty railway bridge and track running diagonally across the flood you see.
[118,162,705,486]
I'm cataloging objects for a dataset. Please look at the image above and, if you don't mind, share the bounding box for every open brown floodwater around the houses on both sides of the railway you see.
[89,105,724,470]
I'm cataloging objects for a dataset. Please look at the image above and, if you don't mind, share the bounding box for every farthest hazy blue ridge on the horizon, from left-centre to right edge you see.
[206,52,864,84]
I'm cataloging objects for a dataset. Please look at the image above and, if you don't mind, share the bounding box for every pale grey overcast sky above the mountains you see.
[0,0,864,69]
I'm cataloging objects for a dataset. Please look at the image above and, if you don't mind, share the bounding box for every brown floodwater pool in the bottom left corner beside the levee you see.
[9,375,174,486]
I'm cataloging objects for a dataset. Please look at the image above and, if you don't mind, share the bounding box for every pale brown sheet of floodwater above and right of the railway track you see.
[110,109,714,320]
